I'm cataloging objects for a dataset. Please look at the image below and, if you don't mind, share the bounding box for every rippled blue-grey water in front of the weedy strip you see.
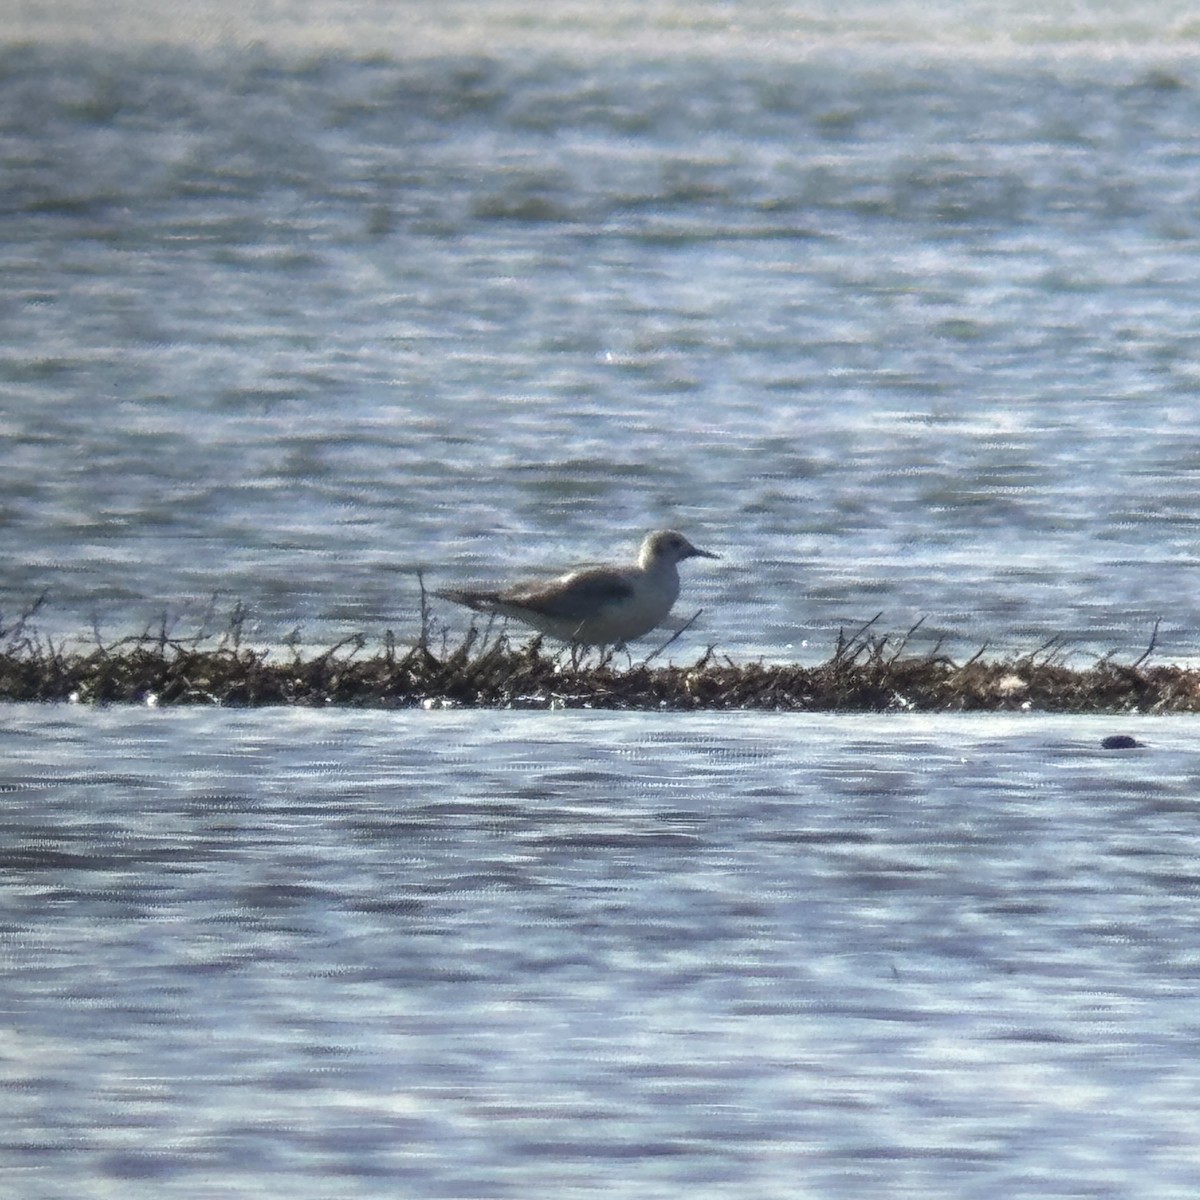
[0,708,1200,1200]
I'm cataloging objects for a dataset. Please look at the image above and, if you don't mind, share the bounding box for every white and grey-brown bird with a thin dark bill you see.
[434,529,720,647]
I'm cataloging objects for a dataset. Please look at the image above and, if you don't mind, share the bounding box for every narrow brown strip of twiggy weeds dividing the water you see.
[0,596,1200,713]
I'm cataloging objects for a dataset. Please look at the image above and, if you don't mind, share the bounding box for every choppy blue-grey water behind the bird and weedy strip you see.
[7,4,1200,660]
